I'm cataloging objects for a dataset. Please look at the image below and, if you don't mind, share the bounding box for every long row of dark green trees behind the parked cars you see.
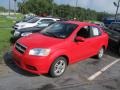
[18,0,109,21]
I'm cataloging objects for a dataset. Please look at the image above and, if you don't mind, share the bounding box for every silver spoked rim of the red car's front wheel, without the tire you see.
[54,60,66,76]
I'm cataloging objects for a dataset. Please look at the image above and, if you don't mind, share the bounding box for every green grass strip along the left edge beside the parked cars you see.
[0,15,21,63]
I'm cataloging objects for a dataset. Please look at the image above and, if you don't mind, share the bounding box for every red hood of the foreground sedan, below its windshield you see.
[17,33,64,48]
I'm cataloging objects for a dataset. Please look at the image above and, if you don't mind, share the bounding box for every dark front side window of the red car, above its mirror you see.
[77,26,90,38]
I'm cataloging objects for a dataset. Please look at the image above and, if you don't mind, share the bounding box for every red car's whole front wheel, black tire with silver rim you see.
[49,57,67,77]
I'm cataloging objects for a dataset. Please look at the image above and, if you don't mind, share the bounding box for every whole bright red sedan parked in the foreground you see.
[12,21,108,77]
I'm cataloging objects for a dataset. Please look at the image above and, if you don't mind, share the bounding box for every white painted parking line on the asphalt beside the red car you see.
[88,59,120,81]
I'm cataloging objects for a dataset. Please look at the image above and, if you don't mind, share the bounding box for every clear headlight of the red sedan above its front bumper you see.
[29,48,50,56]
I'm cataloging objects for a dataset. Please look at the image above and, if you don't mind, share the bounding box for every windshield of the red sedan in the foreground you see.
[40,22,78,38]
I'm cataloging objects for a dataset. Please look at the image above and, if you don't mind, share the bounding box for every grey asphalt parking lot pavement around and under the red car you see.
[0,49,120,90]
